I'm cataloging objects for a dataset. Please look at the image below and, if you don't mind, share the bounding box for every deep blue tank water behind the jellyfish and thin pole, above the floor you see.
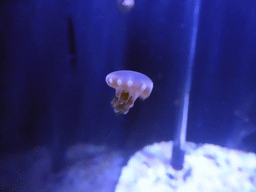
[0,0,256,171]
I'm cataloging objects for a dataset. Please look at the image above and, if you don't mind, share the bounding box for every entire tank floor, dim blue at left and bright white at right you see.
[0,141,256,192]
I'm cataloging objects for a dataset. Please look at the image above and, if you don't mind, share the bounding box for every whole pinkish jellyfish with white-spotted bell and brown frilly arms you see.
[106,70,153,114]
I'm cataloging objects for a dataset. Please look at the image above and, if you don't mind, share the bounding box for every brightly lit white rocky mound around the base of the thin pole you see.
[115,141,256,192]
